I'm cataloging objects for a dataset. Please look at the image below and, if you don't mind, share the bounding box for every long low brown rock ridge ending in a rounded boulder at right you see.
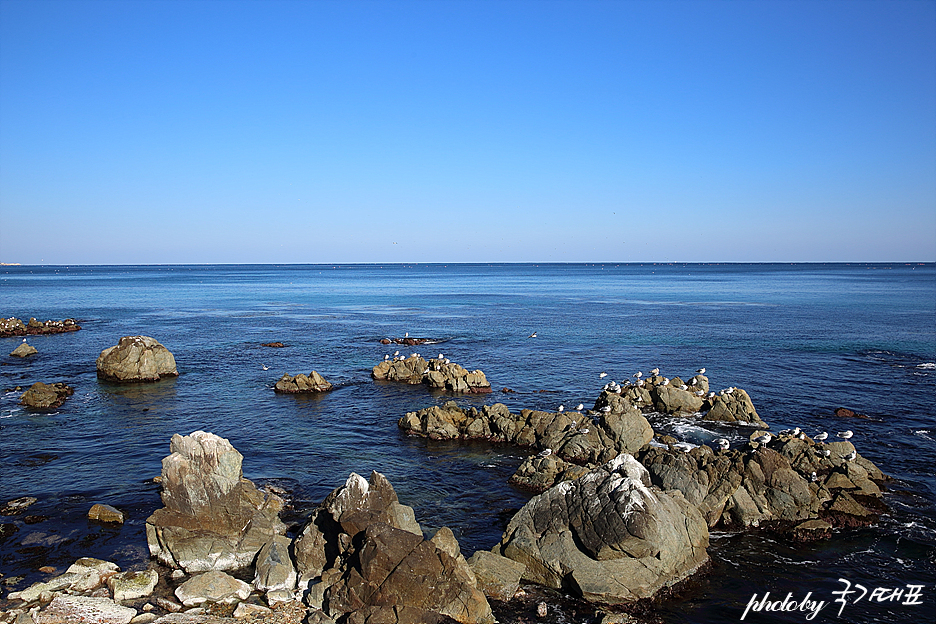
[398,402,653,470]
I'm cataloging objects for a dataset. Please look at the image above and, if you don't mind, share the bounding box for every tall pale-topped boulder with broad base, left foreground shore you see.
[146,431,286,573]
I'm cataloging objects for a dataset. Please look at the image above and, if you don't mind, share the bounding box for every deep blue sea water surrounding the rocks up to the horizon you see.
[0,263,936,623]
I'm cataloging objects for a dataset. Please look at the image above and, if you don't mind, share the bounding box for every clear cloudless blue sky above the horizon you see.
[0,0,936,264]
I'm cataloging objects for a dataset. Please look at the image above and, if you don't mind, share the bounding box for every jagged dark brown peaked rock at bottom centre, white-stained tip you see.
[294,472,493,624]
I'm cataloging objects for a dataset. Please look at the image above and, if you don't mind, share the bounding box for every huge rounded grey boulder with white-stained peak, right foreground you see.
[494,454,708,604]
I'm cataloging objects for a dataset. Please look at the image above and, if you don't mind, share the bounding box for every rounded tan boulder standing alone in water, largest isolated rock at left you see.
[97,336,179,382]
